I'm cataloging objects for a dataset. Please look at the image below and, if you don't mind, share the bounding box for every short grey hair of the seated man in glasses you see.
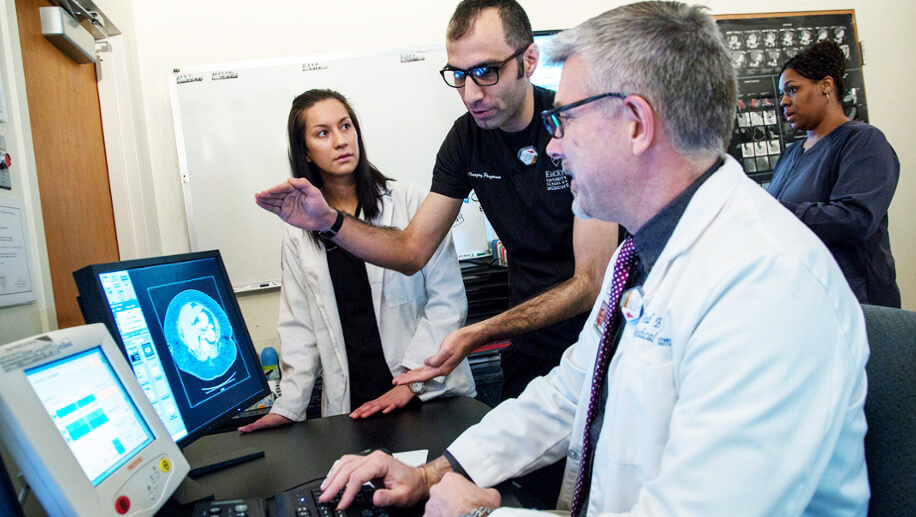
[547,2,737,155]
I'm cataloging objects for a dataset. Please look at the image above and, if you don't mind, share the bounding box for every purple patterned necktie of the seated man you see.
[572,236,636,517]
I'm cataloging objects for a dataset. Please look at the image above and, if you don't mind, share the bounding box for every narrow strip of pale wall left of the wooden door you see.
[0,0,57,344]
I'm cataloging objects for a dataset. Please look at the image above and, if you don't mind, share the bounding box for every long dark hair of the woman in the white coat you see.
[286,89,390,237]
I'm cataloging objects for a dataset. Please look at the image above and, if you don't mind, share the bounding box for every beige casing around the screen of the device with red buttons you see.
[0,323,190,516]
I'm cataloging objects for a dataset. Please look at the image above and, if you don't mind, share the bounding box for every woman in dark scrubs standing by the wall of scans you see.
[767,41,900,307]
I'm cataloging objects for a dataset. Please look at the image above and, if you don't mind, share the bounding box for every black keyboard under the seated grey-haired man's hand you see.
[274,479,423,517]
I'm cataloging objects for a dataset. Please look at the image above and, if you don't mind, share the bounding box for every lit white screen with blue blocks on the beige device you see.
[25,347,153,486]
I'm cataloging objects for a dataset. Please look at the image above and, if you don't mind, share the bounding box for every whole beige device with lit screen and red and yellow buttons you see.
[0,324,189,516]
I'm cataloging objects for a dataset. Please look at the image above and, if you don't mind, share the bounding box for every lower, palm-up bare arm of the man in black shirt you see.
[395,218,618,384]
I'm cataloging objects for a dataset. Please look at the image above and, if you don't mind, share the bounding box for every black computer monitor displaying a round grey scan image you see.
[73,251,269,447]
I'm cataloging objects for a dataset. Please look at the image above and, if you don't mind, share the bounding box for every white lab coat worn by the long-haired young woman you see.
[271,181,476,421]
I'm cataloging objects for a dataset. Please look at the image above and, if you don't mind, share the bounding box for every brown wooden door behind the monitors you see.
[16,0,118,328]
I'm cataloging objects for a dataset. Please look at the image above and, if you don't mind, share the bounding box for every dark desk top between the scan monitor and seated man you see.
[175,397,498,501]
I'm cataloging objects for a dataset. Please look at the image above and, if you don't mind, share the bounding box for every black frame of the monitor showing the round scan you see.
[73,250,270,449]
